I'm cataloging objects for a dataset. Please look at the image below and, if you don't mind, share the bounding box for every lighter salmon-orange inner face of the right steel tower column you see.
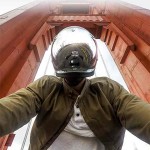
[101,24,149,101]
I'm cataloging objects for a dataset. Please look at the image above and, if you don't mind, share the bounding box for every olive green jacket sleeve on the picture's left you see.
[0,76,52,137]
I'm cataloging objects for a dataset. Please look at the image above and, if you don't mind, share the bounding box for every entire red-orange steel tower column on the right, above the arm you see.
[101,0,150,102]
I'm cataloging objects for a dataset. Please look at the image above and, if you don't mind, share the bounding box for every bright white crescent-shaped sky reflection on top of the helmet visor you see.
[51,26,97,59]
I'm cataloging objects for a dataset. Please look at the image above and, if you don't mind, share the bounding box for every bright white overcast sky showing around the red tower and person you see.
[0,0,150,150]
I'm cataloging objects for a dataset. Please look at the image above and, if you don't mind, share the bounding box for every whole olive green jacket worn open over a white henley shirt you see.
[0,76,150,150]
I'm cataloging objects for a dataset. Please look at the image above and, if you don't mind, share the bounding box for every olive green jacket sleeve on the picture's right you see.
[108,79,150,144]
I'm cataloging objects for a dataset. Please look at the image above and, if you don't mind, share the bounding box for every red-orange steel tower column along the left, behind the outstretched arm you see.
[0,2,49,150]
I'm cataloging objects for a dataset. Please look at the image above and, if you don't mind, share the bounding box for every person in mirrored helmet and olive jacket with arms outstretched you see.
[0,26,150,150]
